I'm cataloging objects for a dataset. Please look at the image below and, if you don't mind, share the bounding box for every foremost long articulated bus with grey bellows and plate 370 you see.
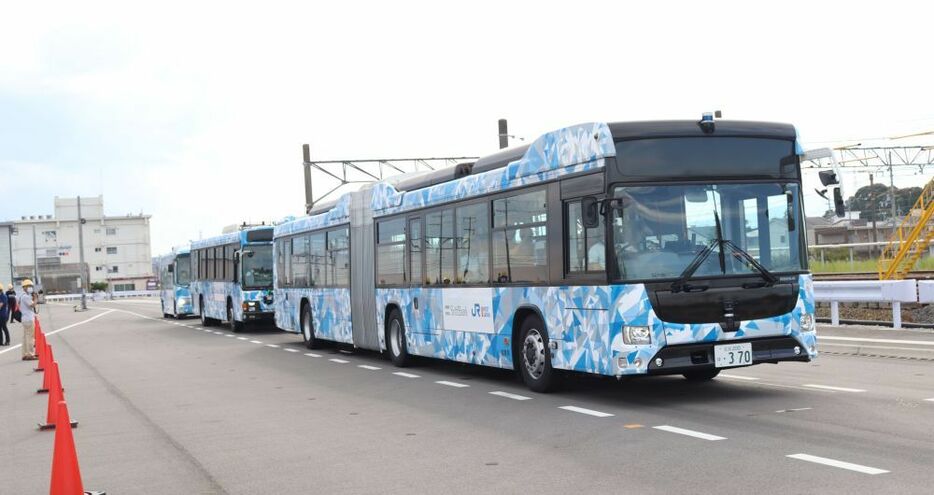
[274,116,817,391]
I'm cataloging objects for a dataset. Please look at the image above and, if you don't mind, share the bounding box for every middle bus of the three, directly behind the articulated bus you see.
[191,226,273,332]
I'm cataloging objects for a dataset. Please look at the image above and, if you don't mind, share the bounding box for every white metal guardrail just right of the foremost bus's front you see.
[814,280,916,328]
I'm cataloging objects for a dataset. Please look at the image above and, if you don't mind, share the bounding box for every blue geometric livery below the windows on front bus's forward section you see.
[376,275,817,376]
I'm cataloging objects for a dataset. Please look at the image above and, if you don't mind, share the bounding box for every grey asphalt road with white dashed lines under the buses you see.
[0,301,934,495]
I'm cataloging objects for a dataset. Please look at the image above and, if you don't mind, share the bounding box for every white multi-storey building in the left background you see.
[10,196,155,293]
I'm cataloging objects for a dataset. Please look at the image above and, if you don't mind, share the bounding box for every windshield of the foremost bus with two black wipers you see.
[609,182,806,280]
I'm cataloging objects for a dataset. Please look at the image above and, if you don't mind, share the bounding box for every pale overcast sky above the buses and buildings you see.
[0,0,934,254]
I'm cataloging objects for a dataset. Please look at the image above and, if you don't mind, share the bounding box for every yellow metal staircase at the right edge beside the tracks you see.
[878,180,934,280]
